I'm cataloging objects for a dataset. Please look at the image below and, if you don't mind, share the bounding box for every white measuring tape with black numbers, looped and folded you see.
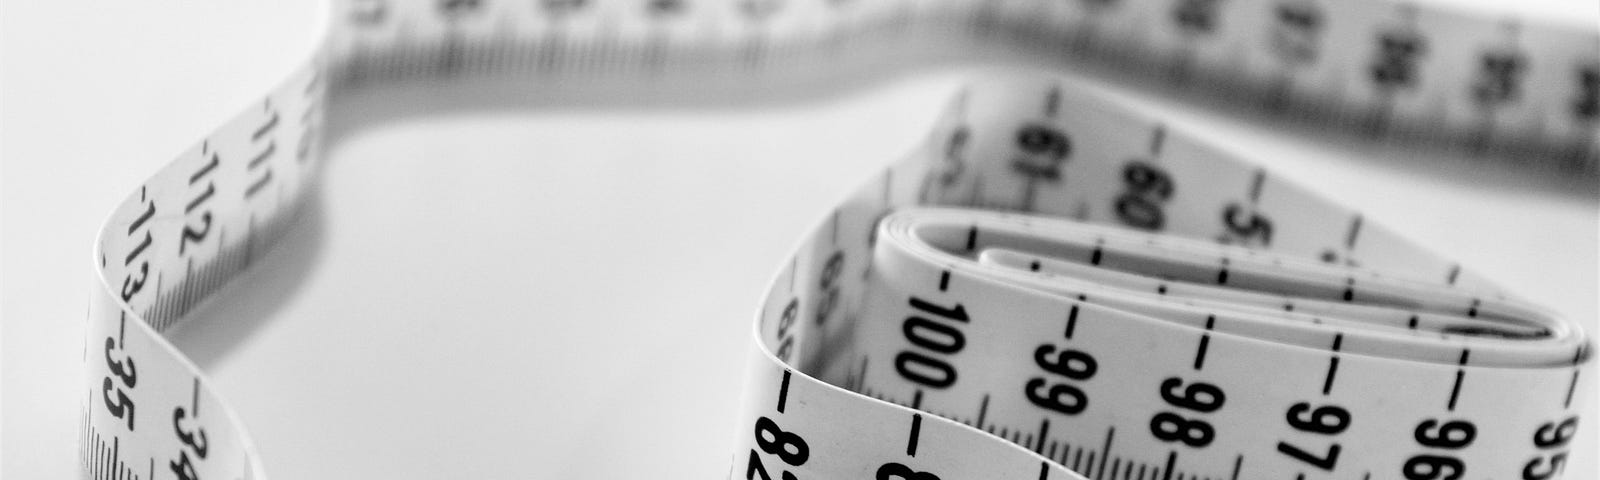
[82,0,1600,480]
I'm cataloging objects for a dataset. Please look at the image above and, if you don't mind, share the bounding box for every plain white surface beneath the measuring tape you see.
[0,2,1600,478]
